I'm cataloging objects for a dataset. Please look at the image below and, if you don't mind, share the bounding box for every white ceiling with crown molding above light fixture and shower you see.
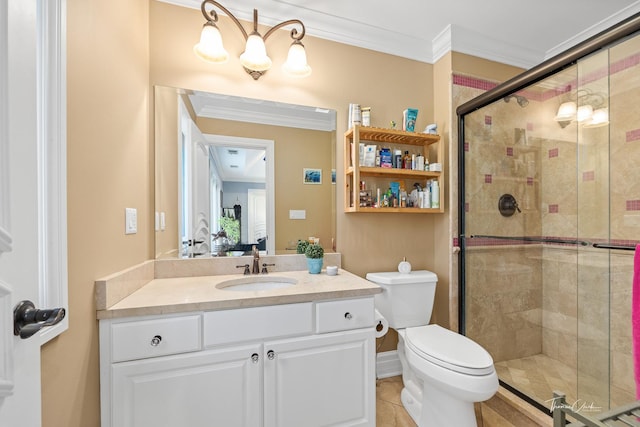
[161,0,640,69]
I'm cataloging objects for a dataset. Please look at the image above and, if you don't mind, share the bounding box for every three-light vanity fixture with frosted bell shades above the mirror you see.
[193,0,311,80]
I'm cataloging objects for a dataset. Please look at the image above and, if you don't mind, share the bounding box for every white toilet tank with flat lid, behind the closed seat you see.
[366,270,438,330]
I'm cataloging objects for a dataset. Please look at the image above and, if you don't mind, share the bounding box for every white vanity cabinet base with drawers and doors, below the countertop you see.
[100,297,375,427]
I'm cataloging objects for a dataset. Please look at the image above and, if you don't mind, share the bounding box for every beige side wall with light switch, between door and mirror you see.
[42,0,153,427]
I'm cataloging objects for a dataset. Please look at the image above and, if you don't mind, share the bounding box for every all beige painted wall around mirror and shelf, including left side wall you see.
[42,0,524,427]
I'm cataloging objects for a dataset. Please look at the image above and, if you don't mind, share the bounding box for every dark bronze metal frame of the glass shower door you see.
[456,9,640,411]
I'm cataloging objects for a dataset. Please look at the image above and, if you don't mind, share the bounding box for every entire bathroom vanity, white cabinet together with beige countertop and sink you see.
[96,258,380,427]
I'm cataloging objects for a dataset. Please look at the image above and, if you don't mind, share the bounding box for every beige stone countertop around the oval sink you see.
[96,256,381,319]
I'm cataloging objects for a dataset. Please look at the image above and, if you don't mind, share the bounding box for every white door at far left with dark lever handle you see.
[0,0,67,427]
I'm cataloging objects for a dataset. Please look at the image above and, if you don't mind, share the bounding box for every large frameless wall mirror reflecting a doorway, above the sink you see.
[154,86,336,258]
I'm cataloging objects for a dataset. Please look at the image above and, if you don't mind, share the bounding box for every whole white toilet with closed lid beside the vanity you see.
[367,270,498,427]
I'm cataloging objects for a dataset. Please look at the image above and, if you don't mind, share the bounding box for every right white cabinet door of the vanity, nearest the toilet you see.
[264,328,375,427]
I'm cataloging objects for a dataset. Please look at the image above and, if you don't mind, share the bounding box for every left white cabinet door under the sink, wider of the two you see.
[110,345,263,427]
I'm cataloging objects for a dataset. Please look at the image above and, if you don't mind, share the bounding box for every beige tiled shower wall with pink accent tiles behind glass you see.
[453,32,640,403]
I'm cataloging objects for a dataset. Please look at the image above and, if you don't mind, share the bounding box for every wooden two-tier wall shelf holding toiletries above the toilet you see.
[344,125,445,214]
